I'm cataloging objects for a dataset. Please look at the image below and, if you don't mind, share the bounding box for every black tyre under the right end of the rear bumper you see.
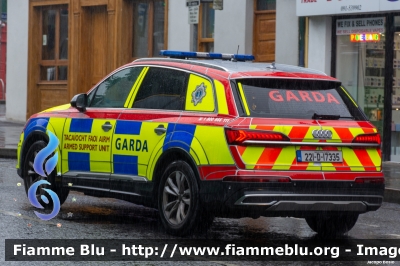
[306,213,358,237]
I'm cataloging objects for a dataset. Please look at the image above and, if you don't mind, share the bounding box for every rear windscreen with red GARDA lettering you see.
[237,79,365,120]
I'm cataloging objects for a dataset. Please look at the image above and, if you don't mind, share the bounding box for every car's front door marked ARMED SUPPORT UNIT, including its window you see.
[62,67,143,191]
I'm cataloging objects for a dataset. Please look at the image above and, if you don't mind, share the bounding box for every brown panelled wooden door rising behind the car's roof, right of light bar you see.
[253,10,276,62]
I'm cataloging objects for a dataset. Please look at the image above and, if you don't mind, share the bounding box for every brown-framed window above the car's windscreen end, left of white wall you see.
[132,0,166,58]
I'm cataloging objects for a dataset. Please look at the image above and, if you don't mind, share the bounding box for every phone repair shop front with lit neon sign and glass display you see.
[297,0,400,162]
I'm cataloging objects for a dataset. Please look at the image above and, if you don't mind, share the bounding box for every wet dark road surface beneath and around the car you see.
[0,159,400,265]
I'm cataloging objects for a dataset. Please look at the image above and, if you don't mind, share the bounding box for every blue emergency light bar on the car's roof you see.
[160,50,255,61]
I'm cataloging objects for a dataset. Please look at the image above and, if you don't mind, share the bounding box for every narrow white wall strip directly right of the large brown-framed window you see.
[168,0,191,51]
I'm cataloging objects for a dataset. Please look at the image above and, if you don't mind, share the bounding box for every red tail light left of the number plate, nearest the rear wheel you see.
[225,129,289,145]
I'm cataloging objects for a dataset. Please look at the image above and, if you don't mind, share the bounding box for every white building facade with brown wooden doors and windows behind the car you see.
[6,0,290,121]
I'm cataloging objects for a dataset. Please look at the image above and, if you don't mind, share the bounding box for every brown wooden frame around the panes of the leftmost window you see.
[39,4,70,84]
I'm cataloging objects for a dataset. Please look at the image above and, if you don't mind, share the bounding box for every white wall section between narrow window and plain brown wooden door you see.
[214,0,254,54]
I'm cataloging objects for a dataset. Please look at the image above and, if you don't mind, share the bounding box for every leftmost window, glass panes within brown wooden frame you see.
[40,6,68,81]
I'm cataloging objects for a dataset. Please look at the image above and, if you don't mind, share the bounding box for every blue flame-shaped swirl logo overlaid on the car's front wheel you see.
[28,131,60,221]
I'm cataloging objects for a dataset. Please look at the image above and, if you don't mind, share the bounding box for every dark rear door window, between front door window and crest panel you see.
[132,67,189,110]
